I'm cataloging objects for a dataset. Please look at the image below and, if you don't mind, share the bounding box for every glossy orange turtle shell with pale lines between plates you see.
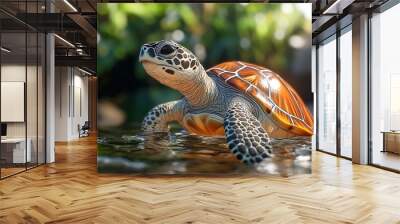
[207,61,313,136]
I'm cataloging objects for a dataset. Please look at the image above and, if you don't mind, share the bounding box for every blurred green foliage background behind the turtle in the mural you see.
[97,3,311,125]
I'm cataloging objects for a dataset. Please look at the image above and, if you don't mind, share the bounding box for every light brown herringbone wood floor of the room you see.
[0,137,400,224]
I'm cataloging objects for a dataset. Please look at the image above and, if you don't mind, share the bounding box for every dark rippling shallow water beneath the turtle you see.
[97,127,311,176]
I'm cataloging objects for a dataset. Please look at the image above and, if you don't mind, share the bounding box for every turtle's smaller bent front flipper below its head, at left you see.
[142,100,185,132]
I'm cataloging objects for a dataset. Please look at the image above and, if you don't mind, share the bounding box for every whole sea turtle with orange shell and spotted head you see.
[139,40,313,164]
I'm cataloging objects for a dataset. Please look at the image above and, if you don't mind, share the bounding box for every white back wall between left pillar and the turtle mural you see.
[55,67,89,141]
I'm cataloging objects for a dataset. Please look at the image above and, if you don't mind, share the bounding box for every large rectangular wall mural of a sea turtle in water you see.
[97,3,314,176]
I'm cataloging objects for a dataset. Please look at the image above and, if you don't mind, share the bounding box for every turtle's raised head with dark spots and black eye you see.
[139,40,204,90]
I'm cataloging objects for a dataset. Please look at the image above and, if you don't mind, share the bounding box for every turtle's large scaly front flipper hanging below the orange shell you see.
[224,102,272,164]
